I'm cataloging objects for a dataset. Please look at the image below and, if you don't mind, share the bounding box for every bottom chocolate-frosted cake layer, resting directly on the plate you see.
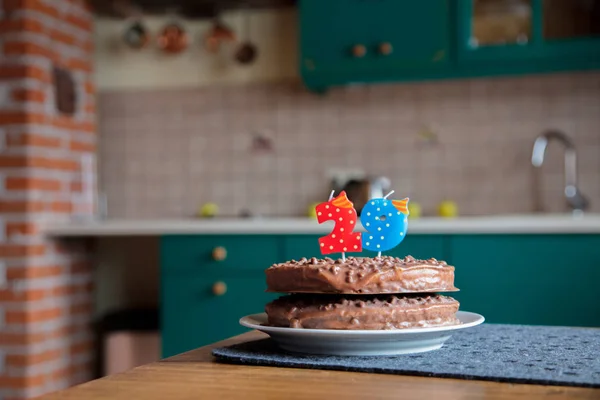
[265,294,460,330]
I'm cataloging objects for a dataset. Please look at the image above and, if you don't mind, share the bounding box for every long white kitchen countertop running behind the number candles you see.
[45,214,600,236]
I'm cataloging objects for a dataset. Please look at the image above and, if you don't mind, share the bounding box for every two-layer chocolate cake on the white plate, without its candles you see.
[265,256,460,330]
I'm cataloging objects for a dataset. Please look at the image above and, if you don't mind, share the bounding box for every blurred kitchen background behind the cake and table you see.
[0,0,600,399]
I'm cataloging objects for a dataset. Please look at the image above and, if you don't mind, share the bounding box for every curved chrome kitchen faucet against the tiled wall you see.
[531,130,588,214]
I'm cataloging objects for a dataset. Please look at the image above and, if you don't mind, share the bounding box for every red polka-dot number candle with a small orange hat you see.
[315,192,362,258]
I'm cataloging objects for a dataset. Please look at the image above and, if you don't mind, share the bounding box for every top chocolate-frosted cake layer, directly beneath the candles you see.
[265,256,458,294]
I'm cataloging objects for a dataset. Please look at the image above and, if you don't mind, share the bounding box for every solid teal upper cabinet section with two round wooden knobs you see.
[300,0,451,89]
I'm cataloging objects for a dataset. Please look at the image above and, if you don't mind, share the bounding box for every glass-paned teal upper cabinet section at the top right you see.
[457,0,600,65]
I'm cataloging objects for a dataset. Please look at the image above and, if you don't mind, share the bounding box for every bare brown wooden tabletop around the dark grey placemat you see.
[43,332,600,400]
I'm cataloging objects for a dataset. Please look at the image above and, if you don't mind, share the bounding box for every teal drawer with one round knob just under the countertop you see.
[160,235,281,274]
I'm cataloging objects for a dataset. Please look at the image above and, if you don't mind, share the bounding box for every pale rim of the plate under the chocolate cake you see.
[239,311,485,336]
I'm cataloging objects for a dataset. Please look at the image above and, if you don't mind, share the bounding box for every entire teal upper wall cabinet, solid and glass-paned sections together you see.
[299,0,600,91]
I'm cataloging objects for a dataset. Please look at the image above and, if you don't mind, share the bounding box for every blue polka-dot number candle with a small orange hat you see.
[360,193,408,252]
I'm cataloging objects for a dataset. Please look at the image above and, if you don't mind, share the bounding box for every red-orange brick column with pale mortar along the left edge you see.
[0,0,96,399]
